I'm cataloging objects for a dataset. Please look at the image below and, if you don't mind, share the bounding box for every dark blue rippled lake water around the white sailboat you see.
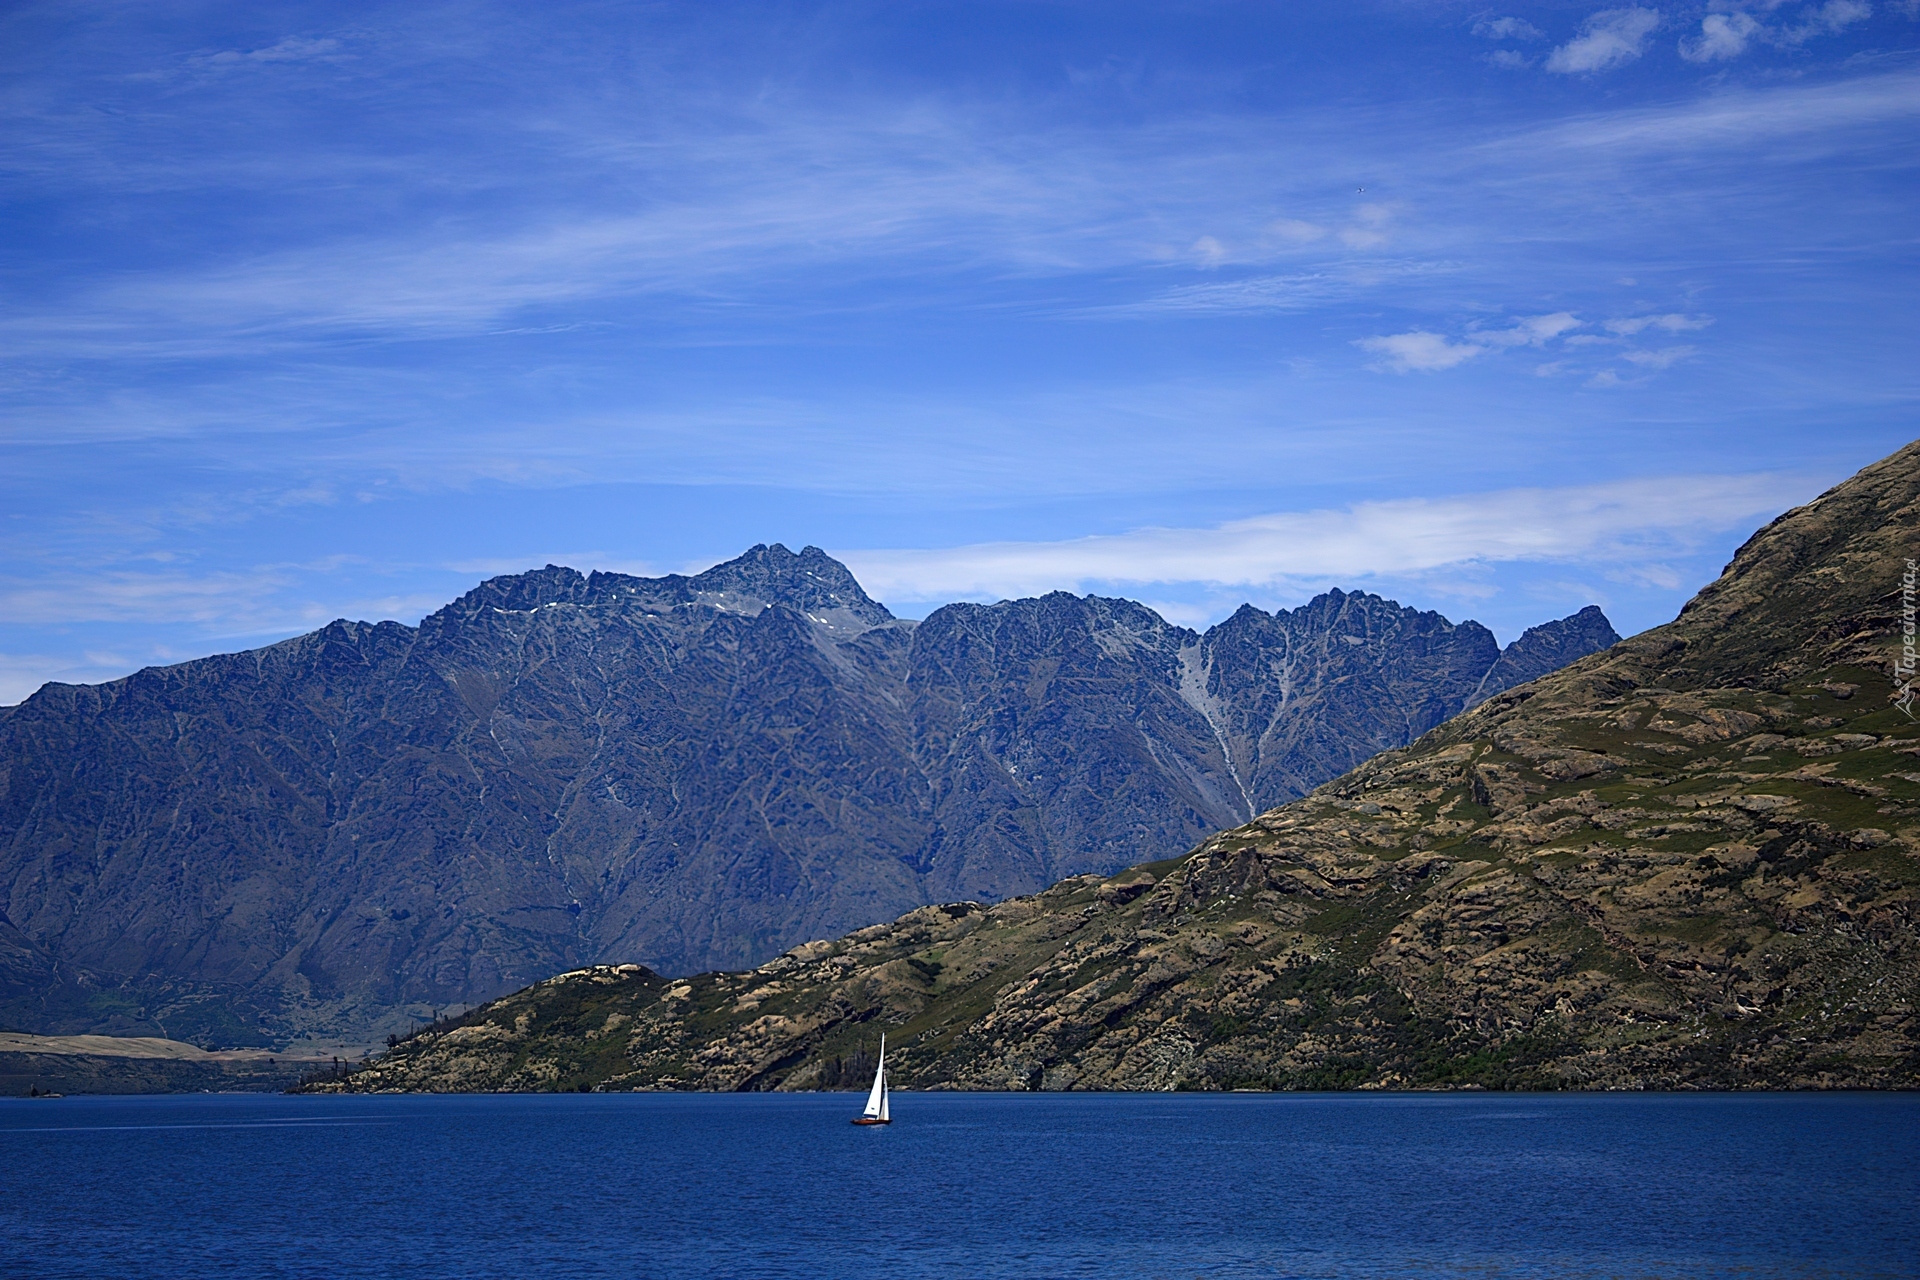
[0,1094,1920,1280]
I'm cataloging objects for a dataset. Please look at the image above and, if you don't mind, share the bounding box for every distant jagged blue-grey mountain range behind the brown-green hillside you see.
[0,545,1617,1044]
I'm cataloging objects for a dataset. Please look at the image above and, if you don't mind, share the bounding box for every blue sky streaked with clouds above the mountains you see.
[0,0,1920,702]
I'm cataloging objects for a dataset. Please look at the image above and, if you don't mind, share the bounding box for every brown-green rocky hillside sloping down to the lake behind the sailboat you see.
[311,445,1920,1090]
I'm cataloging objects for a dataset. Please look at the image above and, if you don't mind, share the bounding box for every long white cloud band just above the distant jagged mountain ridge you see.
[833,474,1811,601]
